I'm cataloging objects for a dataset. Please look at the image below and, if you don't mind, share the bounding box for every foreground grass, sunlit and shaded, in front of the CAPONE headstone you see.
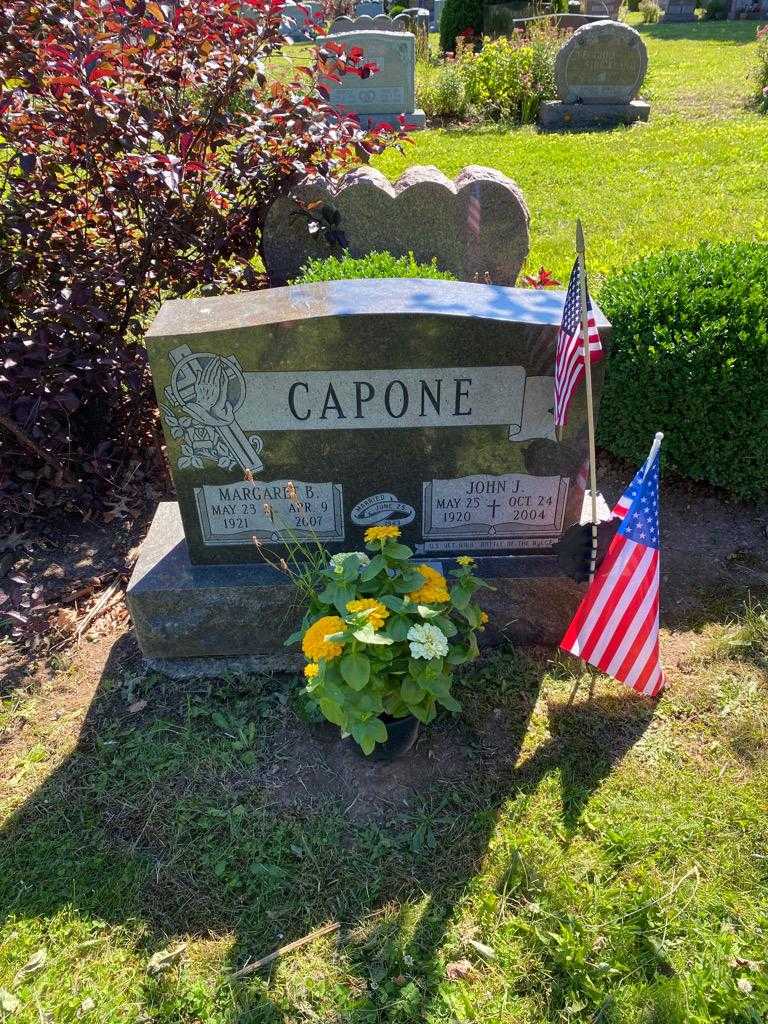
[0,593,768,1024]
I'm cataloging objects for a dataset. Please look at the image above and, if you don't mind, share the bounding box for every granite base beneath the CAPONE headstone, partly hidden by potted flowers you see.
[126,502,584,678]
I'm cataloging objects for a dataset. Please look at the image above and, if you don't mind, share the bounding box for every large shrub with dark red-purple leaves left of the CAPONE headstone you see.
[0,0,405,523]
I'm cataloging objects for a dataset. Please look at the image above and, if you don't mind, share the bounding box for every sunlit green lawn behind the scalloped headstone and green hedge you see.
[376,22,768,276]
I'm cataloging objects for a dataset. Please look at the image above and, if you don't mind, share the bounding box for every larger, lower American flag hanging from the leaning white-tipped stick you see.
[560,446,665,696]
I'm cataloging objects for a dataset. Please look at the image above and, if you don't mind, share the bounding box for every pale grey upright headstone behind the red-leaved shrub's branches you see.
[323,30,425,128]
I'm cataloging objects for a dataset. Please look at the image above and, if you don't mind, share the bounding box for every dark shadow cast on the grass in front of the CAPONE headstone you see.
[0,637,653,1024]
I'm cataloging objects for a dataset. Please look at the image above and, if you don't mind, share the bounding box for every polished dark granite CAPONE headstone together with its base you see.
[128,280,610,658]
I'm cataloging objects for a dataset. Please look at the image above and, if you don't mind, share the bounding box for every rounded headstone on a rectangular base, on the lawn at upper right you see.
[539,20,649,127]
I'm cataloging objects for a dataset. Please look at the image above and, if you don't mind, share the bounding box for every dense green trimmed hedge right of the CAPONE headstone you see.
[599,243,768,501]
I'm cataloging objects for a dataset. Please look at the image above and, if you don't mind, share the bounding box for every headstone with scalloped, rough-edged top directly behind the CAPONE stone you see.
[262,163,530,285]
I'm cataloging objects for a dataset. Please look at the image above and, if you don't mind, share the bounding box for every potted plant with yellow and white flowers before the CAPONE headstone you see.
[287,525,487,760]
